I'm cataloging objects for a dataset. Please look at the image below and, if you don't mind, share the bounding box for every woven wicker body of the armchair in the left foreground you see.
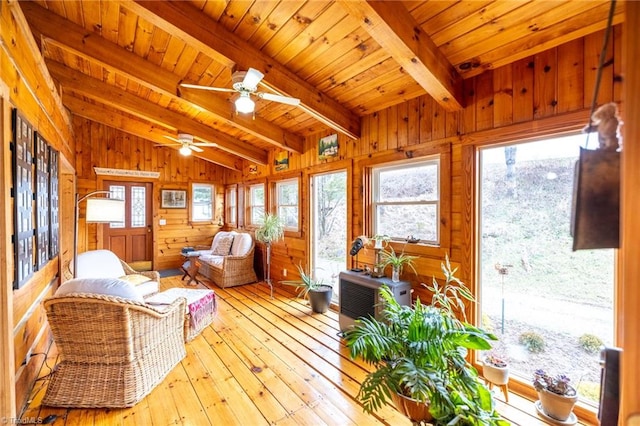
[42,293,186,408]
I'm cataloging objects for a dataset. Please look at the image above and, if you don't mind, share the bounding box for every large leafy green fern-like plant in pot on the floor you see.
[345,258,508,425]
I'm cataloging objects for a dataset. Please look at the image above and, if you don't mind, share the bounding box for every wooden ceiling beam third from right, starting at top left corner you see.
[20,2,304,153]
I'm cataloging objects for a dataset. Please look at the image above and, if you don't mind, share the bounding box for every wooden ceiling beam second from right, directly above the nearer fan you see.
[121,1,360,139]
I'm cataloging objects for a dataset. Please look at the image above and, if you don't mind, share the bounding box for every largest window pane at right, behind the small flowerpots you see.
[477,135,615,405]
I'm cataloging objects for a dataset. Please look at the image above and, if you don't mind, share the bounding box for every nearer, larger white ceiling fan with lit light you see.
[180,68,300,113]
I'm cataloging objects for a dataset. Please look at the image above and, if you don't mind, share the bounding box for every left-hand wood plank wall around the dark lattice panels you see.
[0,1,73,421]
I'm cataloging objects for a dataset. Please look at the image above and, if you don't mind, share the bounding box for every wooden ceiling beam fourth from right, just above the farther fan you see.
[46,60,267,164]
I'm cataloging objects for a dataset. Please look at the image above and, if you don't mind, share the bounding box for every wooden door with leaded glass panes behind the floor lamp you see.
[103,181,153,270]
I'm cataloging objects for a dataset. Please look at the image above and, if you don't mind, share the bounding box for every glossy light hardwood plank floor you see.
[22,276,584,426]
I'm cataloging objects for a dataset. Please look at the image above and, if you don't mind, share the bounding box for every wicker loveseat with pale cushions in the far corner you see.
[198,231,258,288]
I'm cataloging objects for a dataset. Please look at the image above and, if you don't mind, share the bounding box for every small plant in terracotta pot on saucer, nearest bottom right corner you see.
[533,370,578,422]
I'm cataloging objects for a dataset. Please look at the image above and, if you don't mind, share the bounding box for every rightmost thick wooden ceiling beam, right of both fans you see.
[340,0,464,111]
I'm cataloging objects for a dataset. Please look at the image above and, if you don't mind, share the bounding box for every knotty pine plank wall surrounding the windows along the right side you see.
[226,26,622,306]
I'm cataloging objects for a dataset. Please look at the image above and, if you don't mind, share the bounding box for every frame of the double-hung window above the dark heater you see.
[369,153,440,247]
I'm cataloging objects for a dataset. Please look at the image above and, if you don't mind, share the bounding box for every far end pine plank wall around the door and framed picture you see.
[73,117,224,269]
